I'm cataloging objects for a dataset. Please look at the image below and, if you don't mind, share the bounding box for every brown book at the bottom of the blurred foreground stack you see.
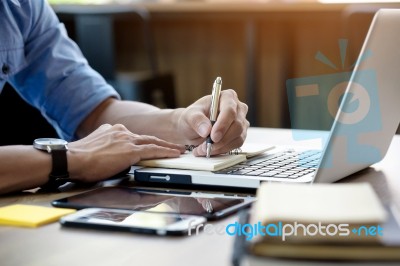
[252,206,400,260]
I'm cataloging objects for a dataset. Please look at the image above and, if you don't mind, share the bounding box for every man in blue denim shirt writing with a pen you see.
[0,0,249,193]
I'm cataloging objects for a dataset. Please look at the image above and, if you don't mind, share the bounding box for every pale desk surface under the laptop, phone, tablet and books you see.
[0,128,400,266]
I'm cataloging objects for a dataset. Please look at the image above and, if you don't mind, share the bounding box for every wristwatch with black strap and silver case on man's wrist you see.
[33,138,71,190]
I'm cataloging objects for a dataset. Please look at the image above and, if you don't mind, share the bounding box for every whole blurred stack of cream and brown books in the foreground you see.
[248,183,400,261]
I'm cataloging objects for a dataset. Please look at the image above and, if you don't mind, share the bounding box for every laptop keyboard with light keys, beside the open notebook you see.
[215,150,321,179]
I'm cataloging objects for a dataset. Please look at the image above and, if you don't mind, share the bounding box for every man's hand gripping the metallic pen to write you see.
[178,90,250,156]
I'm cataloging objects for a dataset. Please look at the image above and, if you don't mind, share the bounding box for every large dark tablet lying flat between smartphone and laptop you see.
[52,186,255,220]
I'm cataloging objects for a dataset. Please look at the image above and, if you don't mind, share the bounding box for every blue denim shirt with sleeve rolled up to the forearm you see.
[0,0,119,140]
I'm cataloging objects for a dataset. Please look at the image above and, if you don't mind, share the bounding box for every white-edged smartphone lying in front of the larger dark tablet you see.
[60,208,207,235]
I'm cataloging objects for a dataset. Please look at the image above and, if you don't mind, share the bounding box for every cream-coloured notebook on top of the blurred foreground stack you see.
[252,183,386,224]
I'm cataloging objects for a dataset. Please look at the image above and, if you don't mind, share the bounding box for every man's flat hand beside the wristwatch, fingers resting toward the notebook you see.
[67,124,185,182]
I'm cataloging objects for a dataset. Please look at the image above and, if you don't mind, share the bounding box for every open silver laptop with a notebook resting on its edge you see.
[134,9,400,189]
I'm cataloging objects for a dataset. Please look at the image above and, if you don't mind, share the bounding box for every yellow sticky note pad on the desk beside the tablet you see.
[0,204,76,227]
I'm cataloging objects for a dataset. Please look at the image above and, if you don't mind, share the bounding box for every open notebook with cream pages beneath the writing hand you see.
[137,143,274,171]
